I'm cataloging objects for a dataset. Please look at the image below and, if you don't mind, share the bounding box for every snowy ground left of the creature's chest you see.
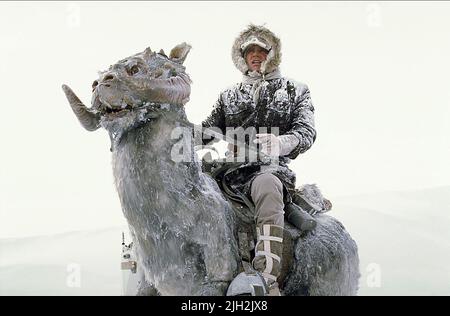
[0,227,123,295]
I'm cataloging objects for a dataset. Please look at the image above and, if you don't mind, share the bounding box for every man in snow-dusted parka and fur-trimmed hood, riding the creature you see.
[202,25,316,294]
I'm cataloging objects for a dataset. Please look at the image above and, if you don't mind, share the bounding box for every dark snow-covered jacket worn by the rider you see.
[202,78,316,199]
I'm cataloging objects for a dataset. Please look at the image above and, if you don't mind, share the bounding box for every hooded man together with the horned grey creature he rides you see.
[63,26,359,295]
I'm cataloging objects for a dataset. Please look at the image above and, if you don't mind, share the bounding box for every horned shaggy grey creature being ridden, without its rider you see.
[63,44,359,295]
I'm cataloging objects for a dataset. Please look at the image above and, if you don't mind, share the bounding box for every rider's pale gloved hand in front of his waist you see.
[253,134,299,157]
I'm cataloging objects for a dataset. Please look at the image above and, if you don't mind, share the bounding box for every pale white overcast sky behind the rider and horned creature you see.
[0,1,450,238]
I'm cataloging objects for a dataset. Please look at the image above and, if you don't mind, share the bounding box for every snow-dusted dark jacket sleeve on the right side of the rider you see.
[286,84,316,159]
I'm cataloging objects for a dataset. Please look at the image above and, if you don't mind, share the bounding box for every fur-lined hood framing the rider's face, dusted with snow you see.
[231,24,281,74]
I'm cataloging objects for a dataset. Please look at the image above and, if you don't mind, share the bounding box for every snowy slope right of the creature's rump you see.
[333,187,450,295]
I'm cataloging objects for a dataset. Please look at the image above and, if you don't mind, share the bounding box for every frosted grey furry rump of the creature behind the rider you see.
[283,214,360,296]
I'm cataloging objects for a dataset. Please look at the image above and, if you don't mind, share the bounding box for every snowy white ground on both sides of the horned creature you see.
[0,187,450,295]
